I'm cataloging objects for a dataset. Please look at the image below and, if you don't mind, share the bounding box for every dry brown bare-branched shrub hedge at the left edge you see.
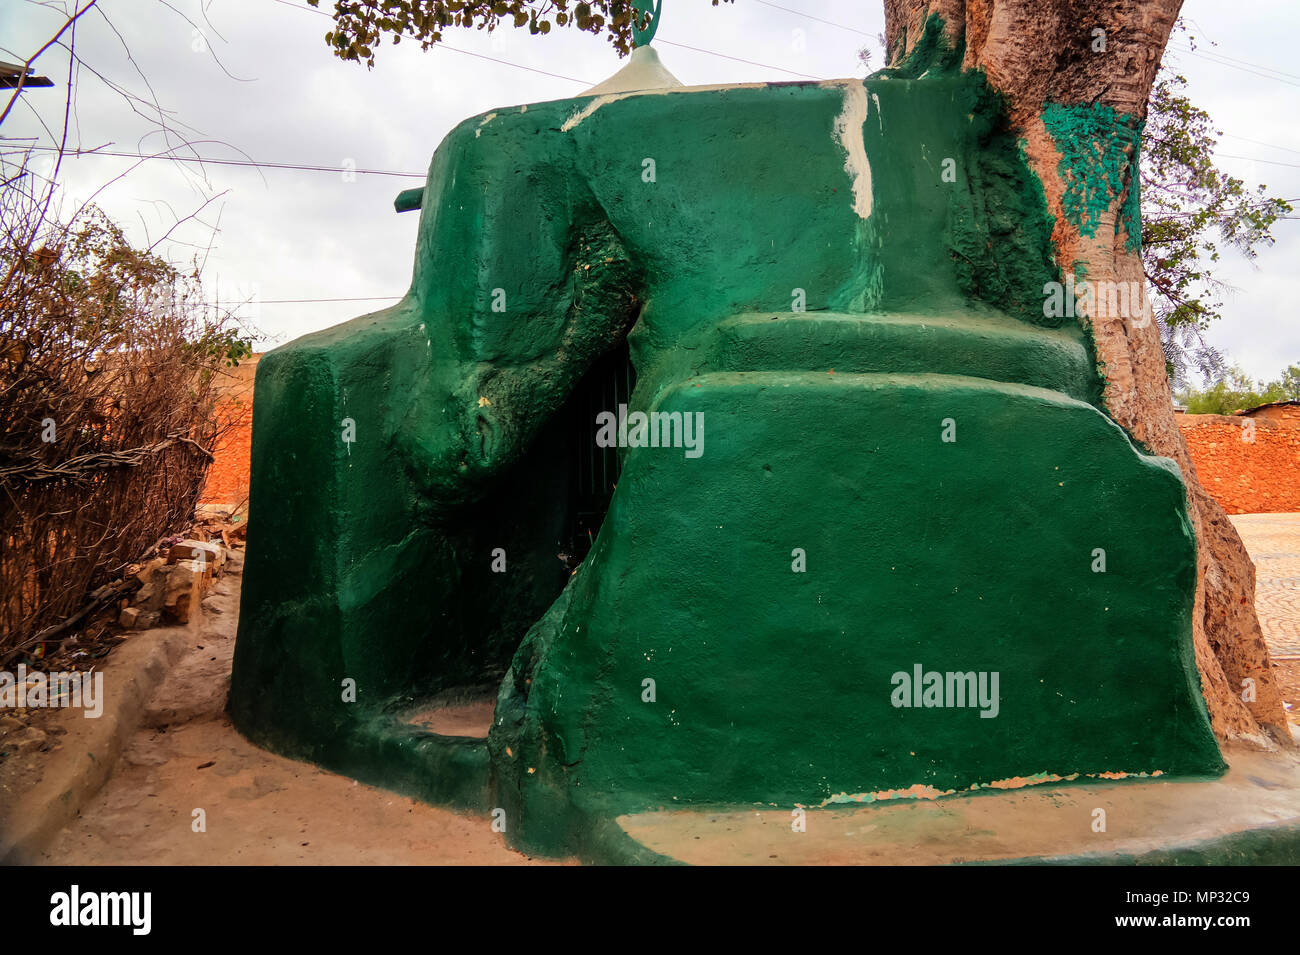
[0,155,250,664]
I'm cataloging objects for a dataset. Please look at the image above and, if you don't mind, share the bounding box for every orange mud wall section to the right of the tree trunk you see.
[1178,404,1300,515]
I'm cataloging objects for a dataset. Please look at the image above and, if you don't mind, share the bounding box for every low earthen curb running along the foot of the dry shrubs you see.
[0,620,198,865]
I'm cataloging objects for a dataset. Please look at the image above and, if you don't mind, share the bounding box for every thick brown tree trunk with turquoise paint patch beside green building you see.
[884,0,1290,748]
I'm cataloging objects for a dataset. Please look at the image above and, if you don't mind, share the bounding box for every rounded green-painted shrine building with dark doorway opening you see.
[230,67,1222,858]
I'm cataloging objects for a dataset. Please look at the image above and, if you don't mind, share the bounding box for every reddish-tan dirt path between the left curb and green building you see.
[32,557,561,865]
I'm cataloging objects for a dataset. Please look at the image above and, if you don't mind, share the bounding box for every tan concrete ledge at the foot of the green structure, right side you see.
[613,747,1300,865]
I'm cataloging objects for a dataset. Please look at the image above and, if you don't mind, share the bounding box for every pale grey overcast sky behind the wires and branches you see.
[0,0,1300,378]
